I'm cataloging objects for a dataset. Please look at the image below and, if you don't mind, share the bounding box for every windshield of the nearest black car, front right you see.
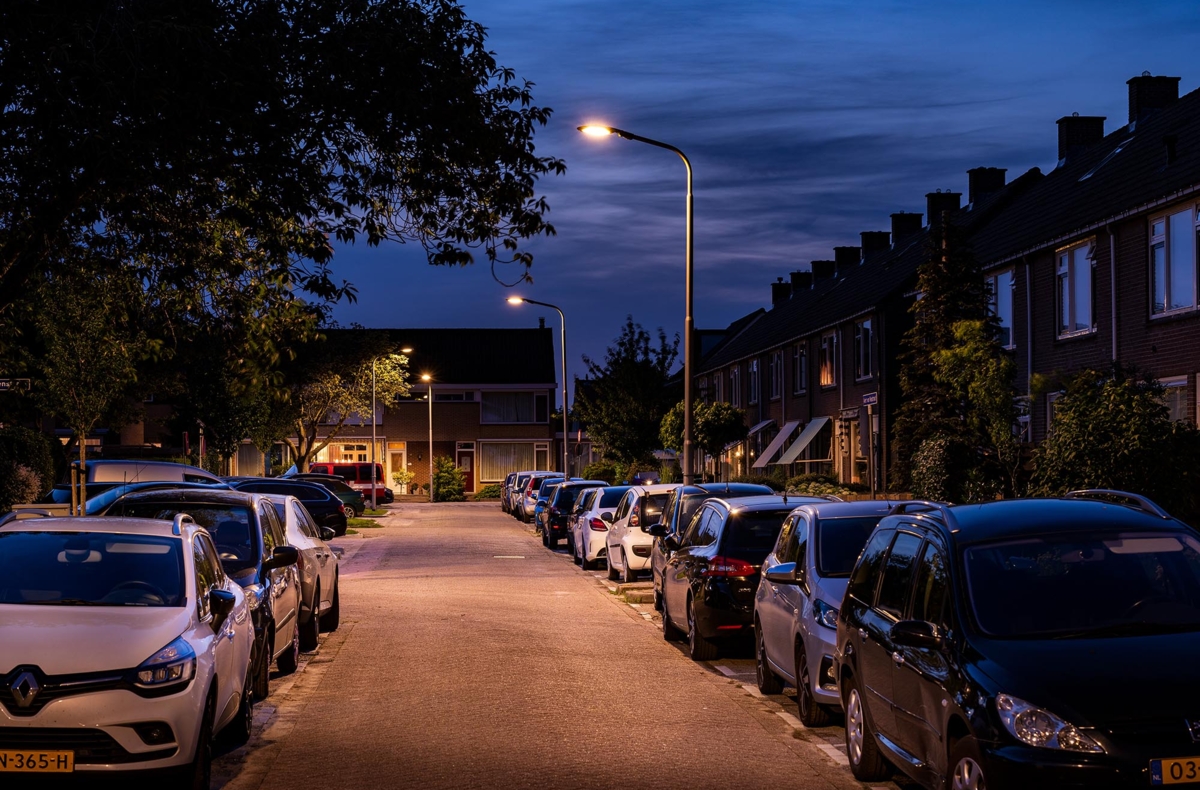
[965,533,1200,639]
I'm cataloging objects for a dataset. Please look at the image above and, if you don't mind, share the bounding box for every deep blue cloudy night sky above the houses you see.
[335,0,1200,401]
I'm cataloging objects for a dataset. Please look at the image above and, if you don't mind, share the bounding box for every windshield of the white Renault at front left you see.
[0,532,187,606]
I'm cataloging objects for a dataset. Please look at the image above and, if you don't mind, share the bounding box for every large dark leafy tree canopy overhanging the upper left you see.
[0,0,565,312]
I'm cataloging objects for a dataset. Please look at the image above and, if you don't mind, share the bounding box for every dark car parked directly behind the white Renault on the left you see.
[104,489,300,700]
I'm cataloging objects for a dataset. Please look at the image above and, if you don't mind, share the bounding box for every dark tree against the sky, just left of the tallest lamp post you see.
[575,316,679,463]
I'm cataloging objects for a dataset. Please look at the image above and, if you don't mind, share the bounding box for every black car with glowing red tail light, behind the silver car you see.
[650,496,826,662]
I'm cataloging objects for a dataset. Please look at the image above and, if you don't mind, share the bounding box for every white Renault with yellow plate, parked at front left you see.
[0,514,254,788]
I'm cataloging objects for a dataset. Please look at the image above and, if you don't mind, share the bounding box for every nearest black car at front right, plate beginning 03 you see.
[835,491,1200,789]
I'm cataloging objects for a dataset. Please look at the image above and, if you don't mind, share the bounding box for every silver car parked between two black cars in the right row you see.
[754,501,892,726]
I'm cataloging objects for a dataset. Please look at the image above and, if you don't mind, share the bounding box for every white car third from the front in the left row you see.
[263,493,342,651]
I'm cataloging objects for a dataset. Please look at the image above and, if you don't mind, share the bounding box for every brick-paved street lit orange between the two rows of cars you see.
[214,503,895,790]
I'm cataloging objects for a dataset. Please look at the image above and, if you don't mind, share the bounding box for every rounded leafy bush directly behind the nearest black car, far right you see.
[1031,366,1200,526]
